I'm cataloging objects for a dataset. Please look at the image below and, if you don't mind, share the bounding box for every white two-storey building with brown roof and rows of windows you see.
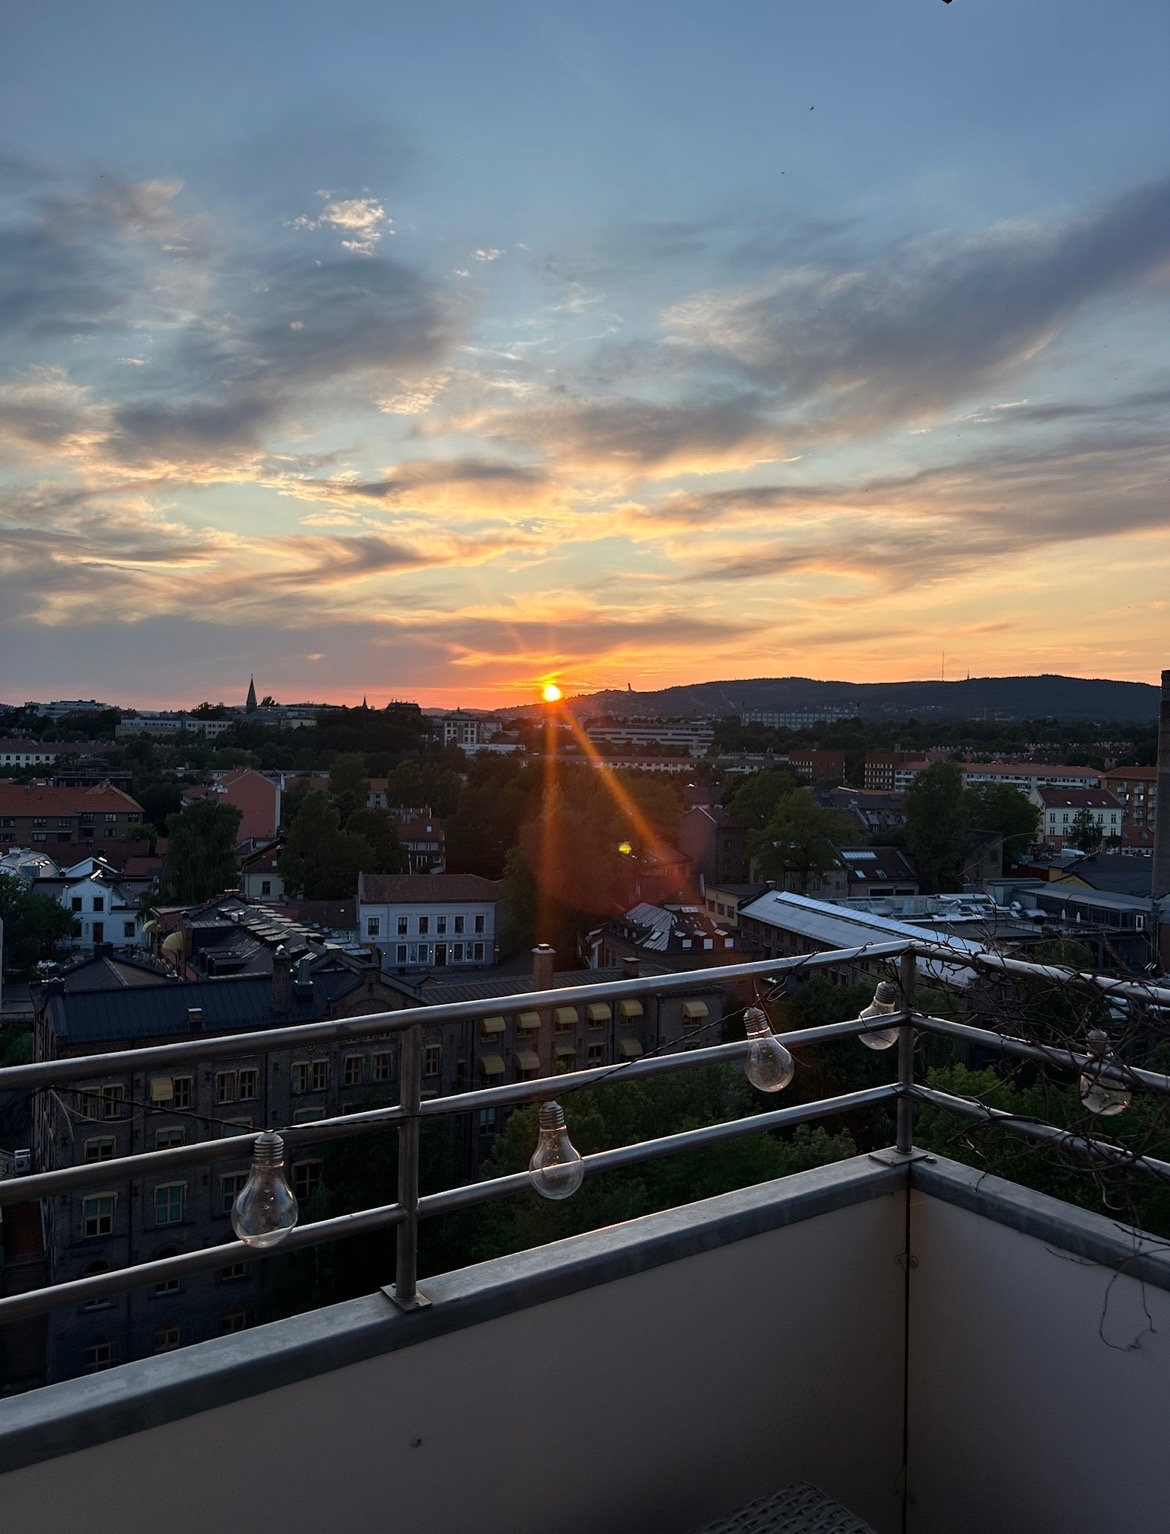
[357,873,500,969]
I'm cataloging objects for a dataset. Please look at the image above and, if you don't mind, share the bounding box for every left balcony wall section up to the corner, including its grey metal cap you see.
[0,1158,906,1534]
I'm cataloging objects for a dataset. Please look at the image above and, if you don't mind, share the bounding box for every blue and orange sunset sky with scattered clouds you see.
[0,0,1170,707]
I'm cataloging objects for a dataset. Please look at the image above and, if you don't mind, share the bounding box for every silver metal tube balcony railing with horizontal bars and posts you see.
[0,940,1170,1324]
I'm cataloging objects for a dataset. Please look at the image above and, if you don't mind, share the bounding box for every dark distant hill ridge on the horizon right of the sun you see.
[497,675,1159,723]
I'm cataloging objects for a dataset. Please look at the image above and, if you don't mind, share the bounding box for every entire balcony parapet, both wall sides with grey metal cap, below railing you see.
[0,1154,1170,1534]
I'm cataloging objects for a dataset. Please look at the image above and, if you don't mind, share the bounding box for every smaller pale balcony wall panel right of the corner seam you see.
[909,1193,1170,1534]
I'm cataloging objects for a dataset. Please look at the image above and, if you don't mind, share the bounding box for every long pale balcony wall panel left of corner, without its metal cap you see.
[0,1192,905,1534]
